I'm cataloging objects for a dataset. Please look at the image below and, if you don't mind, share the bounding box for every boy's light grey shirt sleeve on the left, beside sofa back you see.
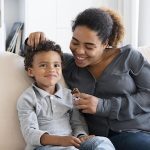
[17,90,47,146]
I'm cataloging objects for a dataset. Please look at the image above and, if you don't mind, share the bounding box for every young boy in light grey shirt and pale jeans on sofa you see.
[17,41,114,150]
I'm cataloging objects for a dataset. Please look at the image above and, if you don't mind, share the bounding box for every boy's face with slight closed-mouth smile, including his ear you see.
[28,51,62,90]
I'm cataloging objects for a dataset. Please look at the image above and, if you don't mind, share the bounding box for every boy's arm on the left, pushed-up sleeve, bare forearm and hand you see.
[17,87,81,147]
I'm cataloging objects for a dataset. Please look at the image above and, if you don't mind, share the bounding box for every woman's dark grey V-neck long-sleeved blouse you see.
[63,45,150,136]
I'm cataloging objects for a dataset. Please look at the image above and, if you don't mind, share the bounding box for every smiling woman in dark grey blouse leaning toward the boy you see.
[27,8,150,150]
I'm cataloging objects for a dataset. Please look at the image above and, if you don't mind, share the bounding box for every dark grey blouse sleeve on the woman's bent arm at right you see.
[96,51,150,121]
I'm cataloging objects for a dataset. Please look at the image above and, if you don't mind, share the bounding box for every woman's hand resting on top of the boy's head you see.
[27,32,47,47]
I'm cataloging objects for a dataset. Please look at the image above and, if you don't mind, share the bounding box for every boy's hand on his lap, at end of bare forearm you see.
[59,136,81,148]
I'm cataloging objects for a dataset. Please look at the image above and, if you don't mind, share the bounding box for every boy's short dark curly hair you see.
[24,40,63,71]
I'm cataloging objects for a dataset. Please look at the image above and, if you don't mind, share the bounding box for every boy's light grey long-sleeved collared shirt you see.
[17,84,87,150]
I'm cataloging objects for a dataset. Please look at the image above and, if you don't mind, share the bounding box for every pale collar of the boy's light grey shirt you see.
[32,83,63,99]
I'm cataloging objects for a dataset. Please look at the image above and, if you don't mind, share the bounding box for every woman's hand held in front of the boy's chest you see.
[74,93,98,114]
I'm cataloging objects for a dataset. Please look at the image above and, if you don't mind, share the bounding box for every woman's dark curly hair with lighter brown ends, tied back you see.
[72,8,124,47]
